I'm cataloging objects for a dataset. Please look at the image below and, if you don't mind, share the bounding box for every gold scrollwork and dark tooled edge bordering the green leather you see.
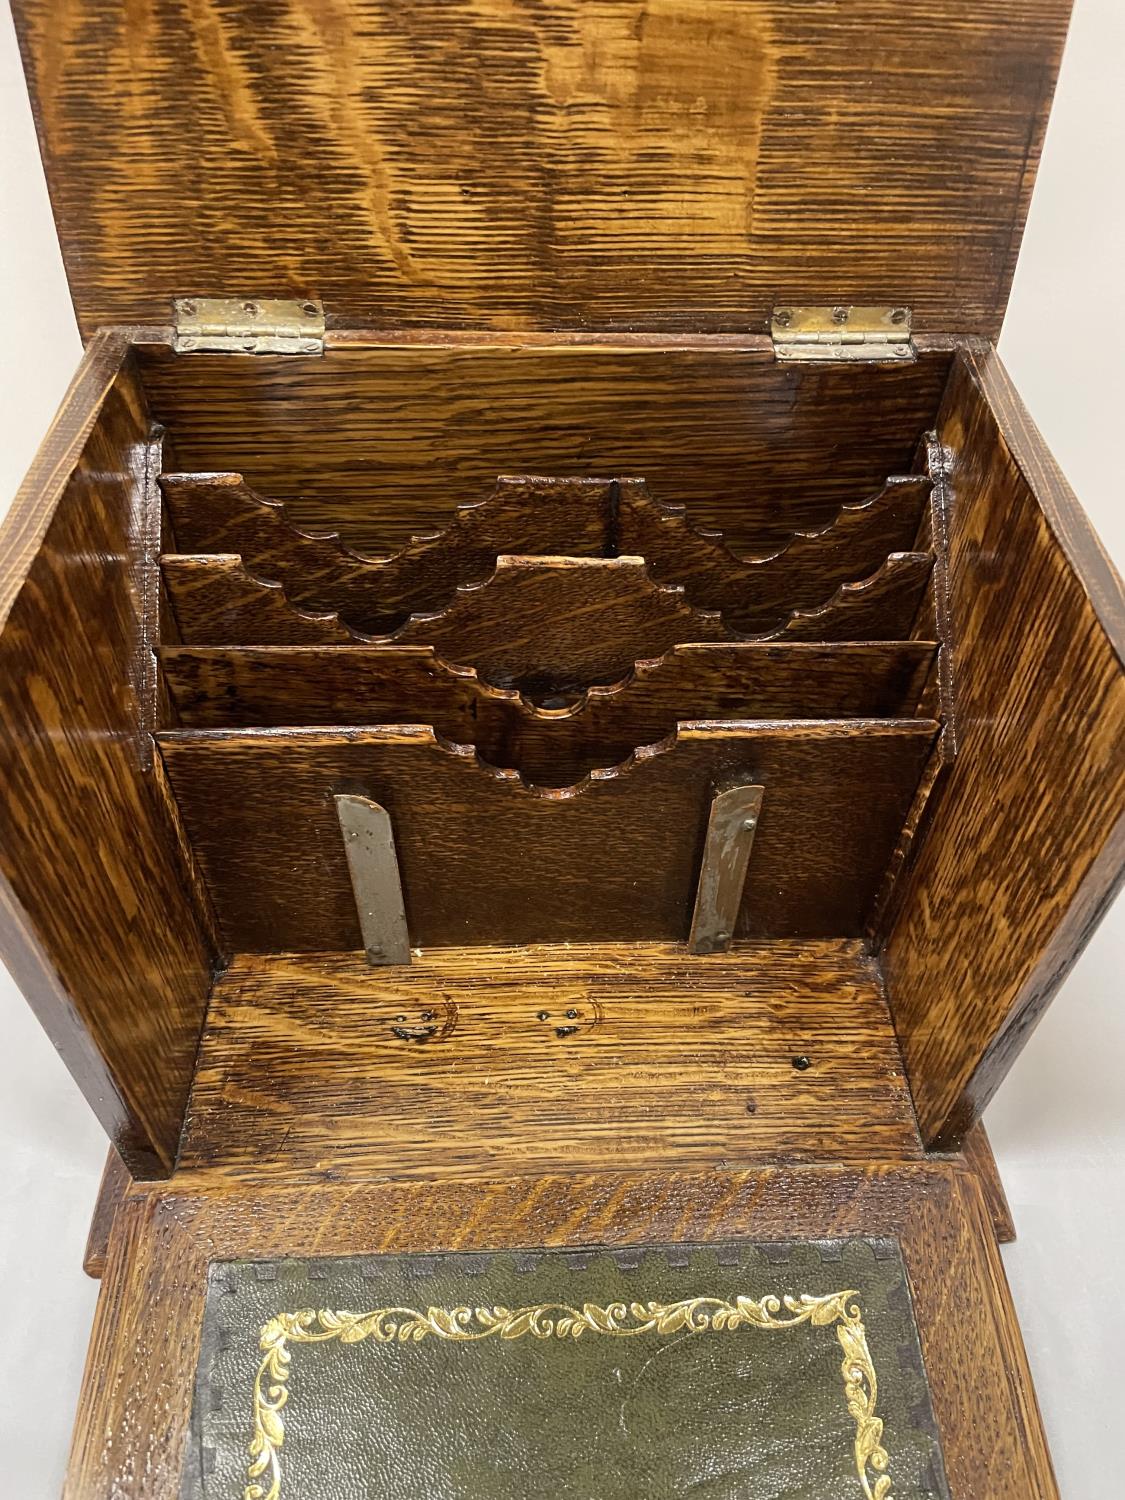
[182,1238,948,1500]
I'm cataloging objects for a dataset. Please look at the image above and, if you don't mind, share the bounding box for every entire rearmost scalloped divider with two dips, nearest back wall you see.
[162,474,930,635]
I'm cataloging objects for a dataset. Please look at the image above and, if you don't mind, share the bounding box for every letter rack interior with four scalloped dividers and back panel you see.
[140,345,951,962]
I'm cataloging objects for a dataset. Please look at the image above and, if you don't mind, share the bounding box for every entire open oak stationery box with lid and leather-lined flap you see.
[0,0,1125,1500]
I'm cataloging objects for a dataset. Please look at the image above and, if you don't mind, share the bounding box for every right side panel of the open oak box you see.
[885,353,1125,1145]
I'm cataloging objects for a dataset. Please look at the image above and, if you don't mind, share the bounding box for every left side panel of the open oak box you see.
[0,336,213,1173]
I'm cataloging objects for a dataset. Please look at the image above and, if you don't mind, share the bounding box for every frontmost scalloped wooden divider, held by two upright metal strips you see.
[159,720,938,953]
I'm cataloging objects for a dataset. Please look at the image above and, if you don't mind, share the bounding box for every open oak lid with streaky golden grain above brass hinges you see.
[14,0,1070,336]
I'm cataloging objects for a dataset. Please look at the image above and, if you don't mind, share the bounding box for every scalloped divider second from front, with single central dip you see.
[161,641,936,786]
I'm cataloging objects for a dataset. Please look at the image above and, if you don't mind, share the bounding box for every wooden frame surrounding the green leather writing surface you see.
[65,1163,1058,1500]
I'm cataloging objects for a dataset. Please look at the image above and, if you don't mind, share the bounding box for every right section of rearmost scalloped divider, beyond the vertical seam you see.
[617,476,930,636]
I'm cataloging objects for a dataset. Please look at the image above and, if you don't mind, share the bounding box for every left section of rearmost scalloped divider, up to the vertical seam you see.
[161,474,627,635]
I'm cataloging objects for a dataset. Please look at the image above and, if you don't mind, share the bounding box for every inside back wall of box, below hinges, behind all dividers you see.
[138,338,950,557]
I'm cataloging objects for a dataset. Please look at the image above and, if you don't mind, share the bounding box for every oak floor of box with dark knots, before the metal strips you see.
[179,942,921,1182]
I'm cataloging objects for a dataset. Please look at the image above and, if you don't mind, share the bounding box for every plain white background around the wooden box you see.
[0,0,1125,1500]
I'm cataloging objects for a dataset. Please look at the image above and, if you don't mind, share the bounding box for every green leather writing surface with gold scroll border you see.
[182,1239,948,1500]
